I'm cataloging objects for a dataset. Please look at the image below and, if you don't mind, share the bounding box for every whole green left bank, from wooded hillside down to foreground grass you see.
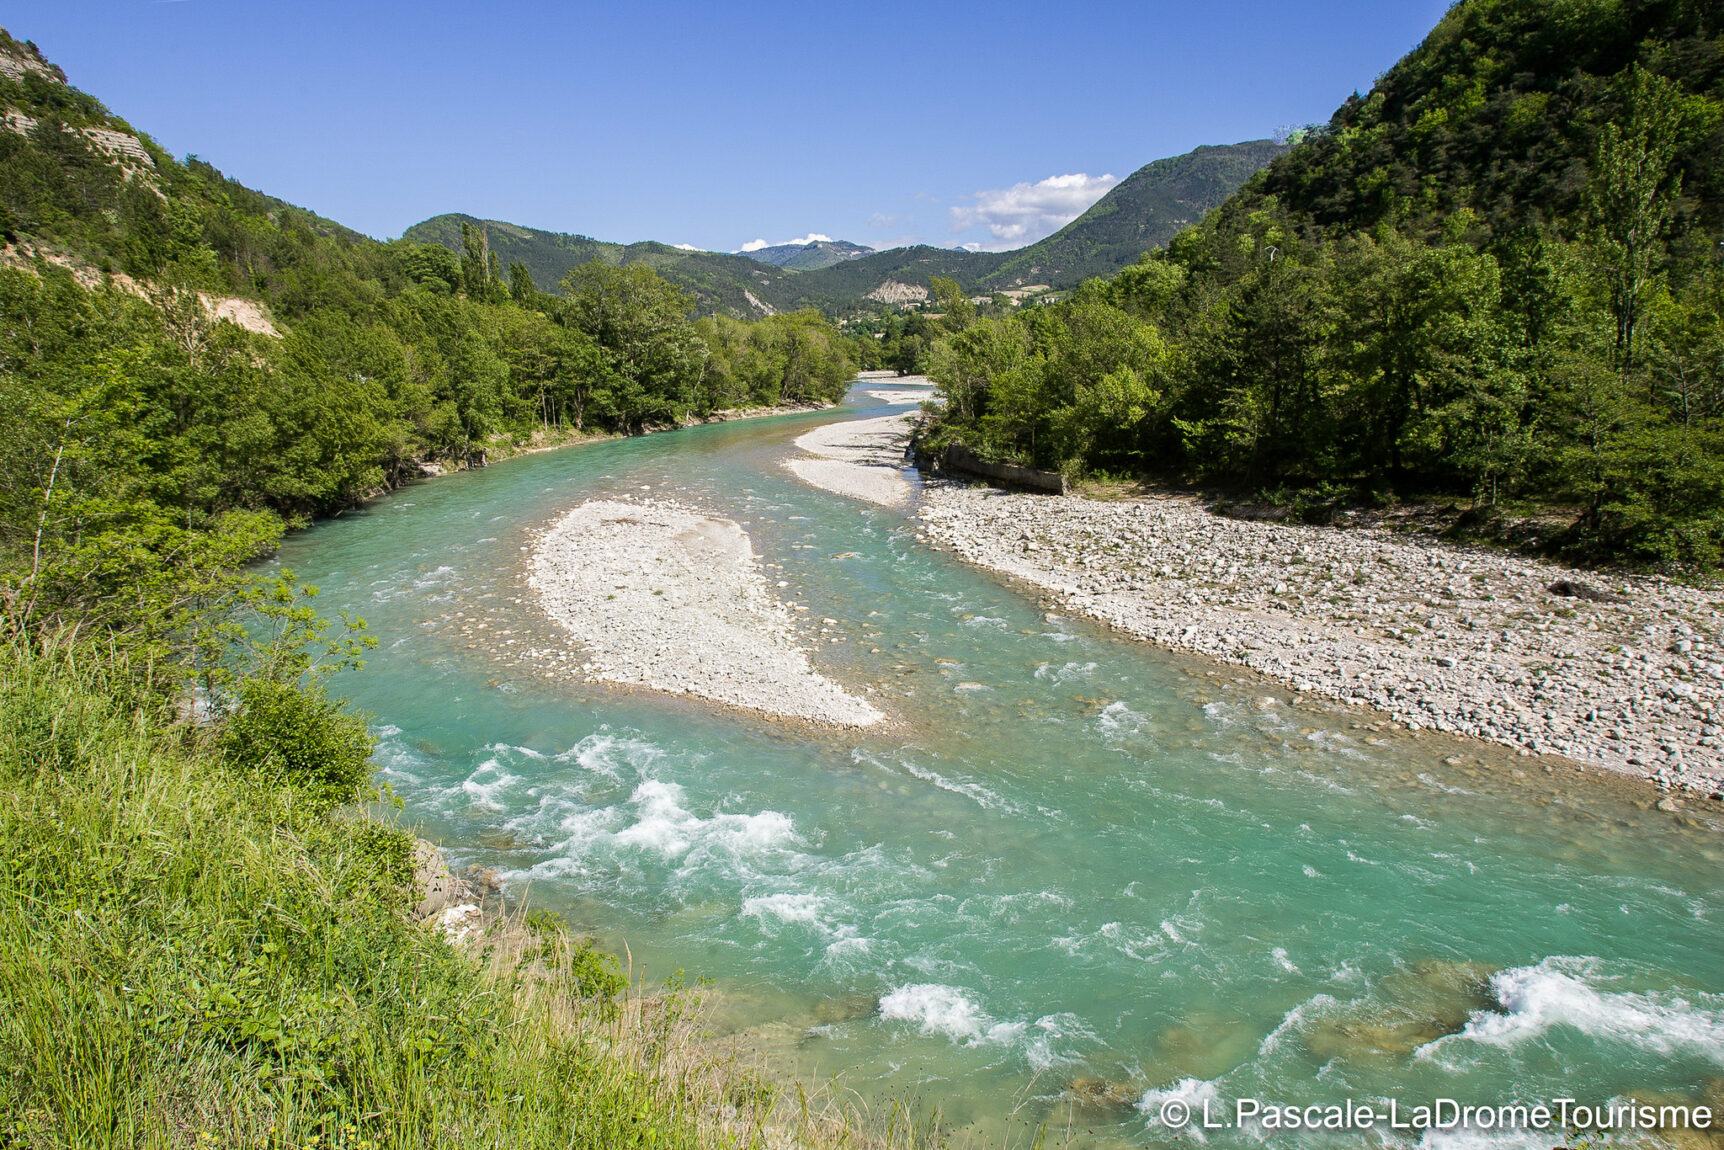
[0,31,852,1148]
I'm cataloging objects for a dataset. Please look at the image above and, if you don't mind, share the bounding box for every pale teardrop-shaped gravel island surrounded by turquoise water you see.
[528,500,884,726]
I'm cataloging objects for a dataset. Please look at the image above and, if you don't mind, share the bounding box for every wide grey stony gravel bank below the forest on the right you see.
[919,481,1724,797]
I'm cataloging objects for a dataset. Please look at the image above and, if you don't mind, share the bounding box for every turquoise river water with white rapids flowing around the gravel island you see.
[281,384,1724,1145]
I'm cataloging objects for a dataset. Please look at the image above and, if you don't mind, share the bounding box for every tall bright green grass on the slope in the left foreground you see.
[0,643,951,1150]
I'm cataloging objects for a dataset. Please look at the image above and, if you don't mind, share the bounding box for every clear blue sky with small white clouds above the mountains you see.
[0,0,1448,252]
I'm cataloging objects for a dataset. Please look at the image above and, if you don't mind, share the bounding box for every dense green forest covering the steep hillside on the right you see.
[929,0,1724,567]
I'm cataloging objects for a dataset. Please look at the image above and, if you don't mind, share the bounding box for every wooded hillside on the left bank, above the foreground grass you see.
[0,24,852,629]
